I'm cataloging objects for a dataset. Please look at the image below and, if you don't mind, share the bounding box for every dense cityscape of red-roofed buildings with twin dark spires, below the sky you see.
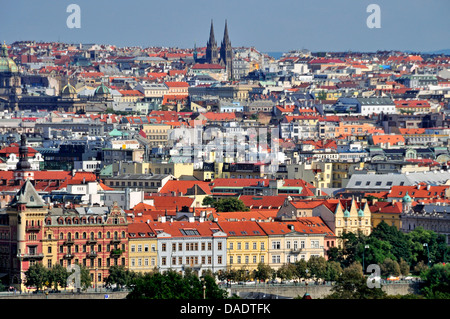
[0,21,450,304]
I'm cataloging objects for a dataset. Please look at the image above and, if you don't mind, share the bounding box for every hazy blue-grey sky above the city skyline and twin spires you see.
[0,0,450,52]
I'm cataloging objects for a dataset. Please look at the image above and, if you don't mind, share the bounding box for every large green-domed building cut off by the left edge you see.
[0,43,22,110]
